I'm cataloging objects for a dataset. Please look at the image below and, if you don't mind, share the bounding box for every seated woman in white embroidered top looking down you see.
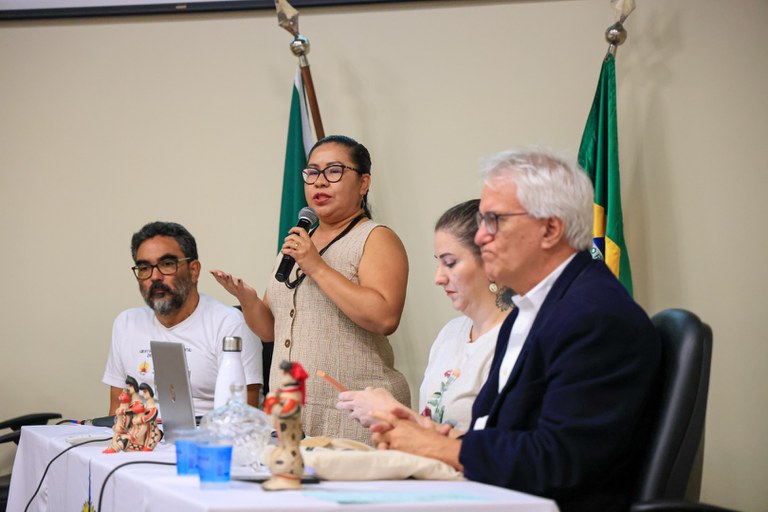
[336,199,512,431]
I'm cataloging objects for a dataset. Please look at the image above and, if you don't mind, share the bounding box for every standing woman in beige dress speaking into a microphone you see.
[211,135,410,443]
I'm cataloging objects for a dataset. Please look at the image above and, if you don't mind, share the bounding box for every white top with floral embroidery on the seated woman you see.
[418,316,501,431]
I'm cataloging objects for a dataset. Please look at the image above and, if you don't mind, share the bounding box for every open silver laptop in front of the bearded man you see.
[149,341,195,443]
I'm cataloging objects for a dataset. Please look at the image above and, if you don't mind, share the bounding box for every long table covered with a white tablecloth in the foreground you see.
[8,425,558,512]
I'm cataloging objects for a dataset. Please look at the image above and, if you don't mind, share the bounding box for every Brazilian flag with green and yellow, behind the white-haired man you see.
[579,54,632,295]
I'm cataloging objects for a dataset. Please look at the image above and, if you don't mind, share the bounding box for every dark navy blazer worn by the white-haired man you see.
[459,252,661,512]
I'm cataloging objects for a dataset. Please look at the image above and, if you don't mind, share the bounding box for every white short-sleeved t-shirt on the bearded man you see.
[102,294,264,416]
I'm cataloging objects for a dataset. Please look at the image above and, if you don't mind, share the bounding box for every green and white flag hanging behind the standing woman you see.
[277,68,313,251]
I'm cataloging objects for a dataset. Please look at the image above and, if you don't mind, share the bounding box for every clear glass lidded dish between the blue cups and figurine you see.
[200,384,272,466]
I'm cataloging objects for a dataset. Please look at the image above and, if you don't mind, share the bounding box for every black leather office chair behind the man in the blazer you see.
[630,309,733,512]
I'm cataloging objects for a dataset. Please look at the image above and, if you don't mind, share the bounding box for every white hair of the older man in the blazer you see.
[480,149,595,250]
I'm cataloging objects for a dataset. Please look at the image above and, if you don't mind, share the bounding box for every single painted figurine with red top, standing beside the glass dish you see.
[261,361,307,491]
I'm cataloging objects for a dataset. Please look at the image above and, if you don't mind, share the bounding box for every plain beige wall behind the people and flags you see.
[0,0,768,510]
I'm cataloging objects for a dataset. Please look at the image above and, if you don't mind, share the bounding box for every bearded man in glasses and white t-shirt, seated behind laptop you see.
[102,222,263,415]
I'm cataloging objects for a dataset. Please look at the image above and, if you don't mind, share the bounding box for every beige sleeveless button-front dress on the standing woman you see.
[267,220,411,443]
